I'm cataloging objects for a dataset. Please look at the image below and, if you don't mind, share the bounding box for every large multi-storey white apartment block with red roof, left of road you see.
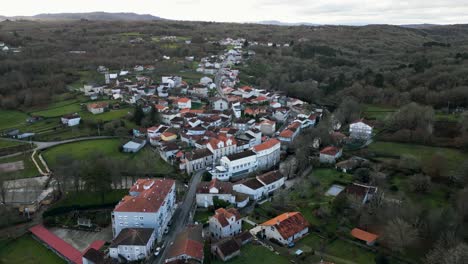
[112,179,176,241]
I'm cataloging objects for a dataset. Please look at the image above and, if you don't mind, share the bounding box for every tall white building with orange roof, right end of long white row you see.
[252,138,281,170]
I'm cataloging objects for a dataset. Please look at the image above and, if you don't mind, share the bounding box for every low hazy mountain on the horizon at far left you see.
[0,12,163,21]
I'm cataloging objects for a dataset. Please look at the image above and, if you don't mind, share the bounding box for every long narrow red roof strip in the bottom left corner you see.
[29,225,83,264]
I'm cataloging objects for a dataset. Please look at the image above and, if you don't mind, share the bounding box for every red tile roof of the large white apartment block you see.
[114,179,175,212]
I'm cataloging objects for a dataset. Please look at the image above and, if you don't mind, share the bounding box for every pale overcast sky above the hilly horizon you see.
[0,0,468,24]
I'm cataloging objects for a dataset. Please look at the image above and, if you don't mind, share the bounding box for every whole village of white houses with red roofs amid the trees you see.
[0,36,383,263]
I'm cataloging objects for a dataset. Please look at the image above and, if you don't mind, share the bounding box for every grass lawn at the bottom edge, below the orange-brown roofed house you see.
[211,244,290,264]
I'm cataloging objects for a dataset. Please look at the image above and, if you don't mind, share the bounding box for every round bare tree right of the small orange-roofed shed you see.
[384,217,418,252]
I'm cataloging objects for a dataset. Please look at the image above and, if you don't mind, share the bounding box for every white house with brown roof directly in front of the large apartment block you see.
[109,228,155,261]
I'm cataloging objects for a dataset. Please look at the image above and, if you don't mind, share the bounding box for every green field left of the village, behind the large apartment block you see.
[42,139,173,174]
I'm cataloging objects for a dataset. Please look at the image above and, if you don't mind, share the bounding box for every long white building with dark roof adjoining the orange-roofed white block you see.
[210,150,257,181]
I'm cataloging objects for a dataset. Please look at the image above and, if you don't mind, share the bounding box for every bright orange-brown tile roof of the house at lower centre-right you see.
[261,212,309,239]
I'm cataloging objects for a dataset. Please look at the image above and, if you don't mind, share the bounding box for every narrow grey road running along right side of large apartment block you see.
[154,170,205,264]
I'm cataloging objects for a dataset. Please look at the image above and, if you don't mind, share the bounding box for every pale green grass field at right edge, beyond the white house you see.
[369,142,468,170]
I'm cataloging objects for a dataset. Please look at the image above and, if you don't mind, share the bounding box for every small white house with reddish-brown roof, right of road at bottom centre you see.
[208,208,242,239]
